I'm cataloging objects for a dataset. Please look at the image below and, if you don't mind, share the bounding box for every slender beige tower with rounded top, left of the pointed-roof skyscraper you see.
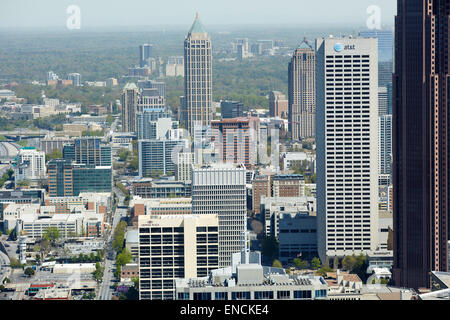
[121,83,139,132]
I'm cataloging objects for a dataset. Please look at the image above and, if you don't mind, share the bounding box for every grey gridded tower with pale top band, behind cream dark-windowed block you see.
[192,164,247,267]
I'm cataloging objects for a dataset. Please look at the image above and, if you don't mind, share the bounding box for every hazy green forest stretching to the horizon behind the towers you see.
[0,25,358,109]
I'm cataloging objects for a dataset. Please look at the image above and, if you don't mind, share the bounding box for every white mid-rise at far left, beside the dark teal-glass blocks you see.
[14,147,47,186]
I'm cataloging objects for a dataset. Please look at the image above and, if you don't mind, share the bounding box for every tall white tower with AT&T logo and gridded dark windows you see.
[316,38,378,262]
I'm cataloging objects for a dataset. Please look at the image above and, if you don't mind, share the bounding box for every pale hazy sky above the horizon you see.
[0,0,397,28]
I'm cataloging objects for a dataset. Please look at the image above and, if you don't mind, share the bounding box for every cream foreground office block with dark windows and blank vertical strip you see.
[138,213,219,300]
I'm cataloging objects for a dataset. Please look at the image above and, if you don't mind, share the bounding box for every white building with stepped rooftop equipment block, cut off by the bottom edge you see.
[175,249,327,300]
